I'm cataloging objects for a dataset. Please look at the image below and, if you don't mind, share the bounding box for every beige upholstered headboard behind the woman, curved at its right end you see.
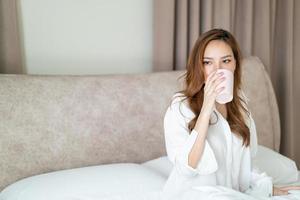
[0,57,280,191]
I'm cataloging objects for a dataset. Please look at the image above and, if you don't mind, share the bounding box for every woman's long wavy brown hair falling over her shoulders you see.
[177,29,250,146]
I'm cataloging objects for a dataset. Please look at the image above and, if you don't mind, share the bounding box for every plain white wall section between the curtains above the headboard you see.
[19,0,152,74]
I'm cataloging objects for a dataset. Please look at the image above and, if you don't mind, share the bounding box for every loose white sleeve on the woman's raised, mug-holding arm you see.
[164,95,218,176]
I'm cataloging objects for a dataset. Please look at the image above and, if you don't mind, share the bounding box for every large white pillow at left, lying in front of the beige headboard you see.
[0,163,165,200]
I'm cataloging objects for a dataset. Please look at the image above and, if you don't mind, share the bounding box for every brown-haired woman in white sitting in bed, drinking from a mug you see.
[163,29,300,199]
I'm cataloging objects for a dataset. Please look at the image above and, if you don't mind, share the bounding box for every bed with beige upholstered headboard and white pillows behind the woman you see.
[0,57,300,200]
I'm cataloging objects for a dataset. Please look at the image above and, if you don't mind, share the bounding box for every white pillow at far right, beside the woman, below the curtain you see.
[252,145,298,184]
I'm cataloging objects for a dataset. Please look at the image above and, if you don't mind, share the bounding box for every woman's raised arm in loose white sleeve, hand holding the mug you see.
[164,69,224,176]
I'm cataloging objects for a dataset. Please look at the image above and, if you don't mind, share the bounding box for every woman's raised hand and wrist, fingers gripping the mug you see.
[201,70,225,116]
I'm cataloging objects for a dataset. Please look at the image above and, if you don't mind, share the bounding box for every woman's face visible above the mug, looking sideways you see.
[202,40,236,80]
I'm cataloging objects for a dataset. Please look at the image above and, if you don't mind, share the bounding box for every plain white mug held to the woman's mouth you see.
[216,69,233,104]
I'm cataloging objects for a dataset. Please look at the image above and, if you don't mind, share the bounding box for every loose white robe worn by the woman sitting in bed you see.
[162,93,273,199]
